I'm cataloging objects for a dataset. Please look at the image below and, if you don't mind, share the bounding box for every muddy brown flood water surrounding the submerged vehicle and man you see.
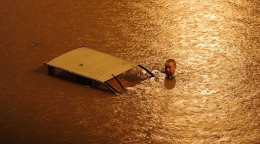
[0,0,260,144]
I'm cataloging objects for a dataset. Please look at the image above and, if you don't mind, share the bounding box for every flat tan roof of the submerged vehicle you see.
[46,47,138,82]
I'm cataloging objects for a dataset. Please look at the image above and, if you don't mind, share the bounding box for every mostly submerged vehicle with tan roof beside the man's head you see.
[45,47,154,94]
